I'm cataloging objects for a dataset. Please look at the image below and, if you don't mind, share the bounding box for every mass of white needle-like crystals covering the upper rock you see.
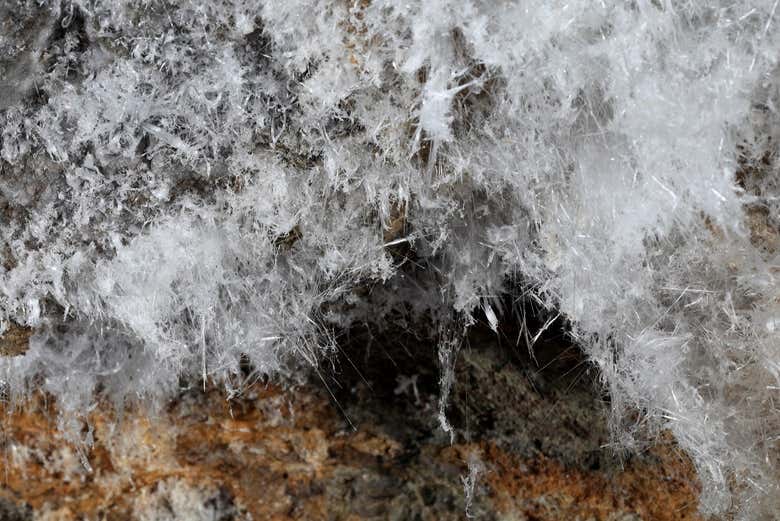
[0,0,780,519]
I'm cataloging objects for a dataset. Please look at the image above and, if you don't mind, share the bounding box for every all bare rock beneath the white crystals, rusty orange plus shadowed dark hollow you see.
[0,333,699,521]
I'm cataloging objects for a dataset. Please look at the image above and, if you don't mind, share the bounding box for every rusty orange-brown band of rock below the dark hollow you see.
[0,378,698,520]
